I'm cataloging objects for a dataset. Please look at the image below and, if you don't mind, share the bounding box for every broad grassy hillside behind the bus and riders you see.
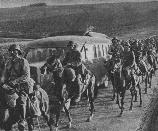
[0,2,158,38]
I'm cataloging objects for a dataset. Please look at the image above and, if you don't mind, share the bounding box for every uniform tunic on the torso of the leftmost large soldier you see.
[6,58,33,94]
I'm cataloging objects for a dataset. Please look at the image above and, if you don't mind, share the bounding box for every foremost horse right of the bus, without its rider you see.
[105,59,142,116]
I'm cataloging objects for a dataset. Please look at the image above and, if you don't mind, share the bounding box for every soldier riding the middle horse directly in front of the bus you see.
[63,41,91,102]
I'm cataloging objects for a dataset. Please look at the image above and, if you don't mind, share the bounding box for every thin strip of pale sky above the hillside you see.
[0,0,158,8]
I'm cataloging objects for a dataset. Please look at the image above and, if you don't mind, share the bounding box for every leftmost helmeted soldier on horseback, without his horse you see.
[5,44,35,128]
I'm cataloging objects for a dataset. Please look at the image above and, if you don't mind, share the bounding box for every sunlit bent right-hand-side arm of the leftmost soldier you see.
[14,59,30,83]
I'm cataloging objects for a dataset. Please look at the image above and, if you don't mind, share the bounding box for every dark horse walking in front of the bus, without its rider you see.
[41,61,95,128]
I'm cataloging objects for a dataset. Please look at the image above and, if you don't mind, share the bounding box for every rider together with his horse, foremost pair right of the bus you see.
[110,42,142,115]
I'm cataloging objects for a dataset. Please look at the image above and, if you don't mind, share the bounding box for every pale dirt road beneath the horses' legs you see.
[26,72,158,131]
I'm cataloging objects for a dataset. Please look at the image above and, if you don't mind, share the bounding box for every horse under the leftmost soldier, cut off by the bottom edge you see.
[0,59,52,131]
